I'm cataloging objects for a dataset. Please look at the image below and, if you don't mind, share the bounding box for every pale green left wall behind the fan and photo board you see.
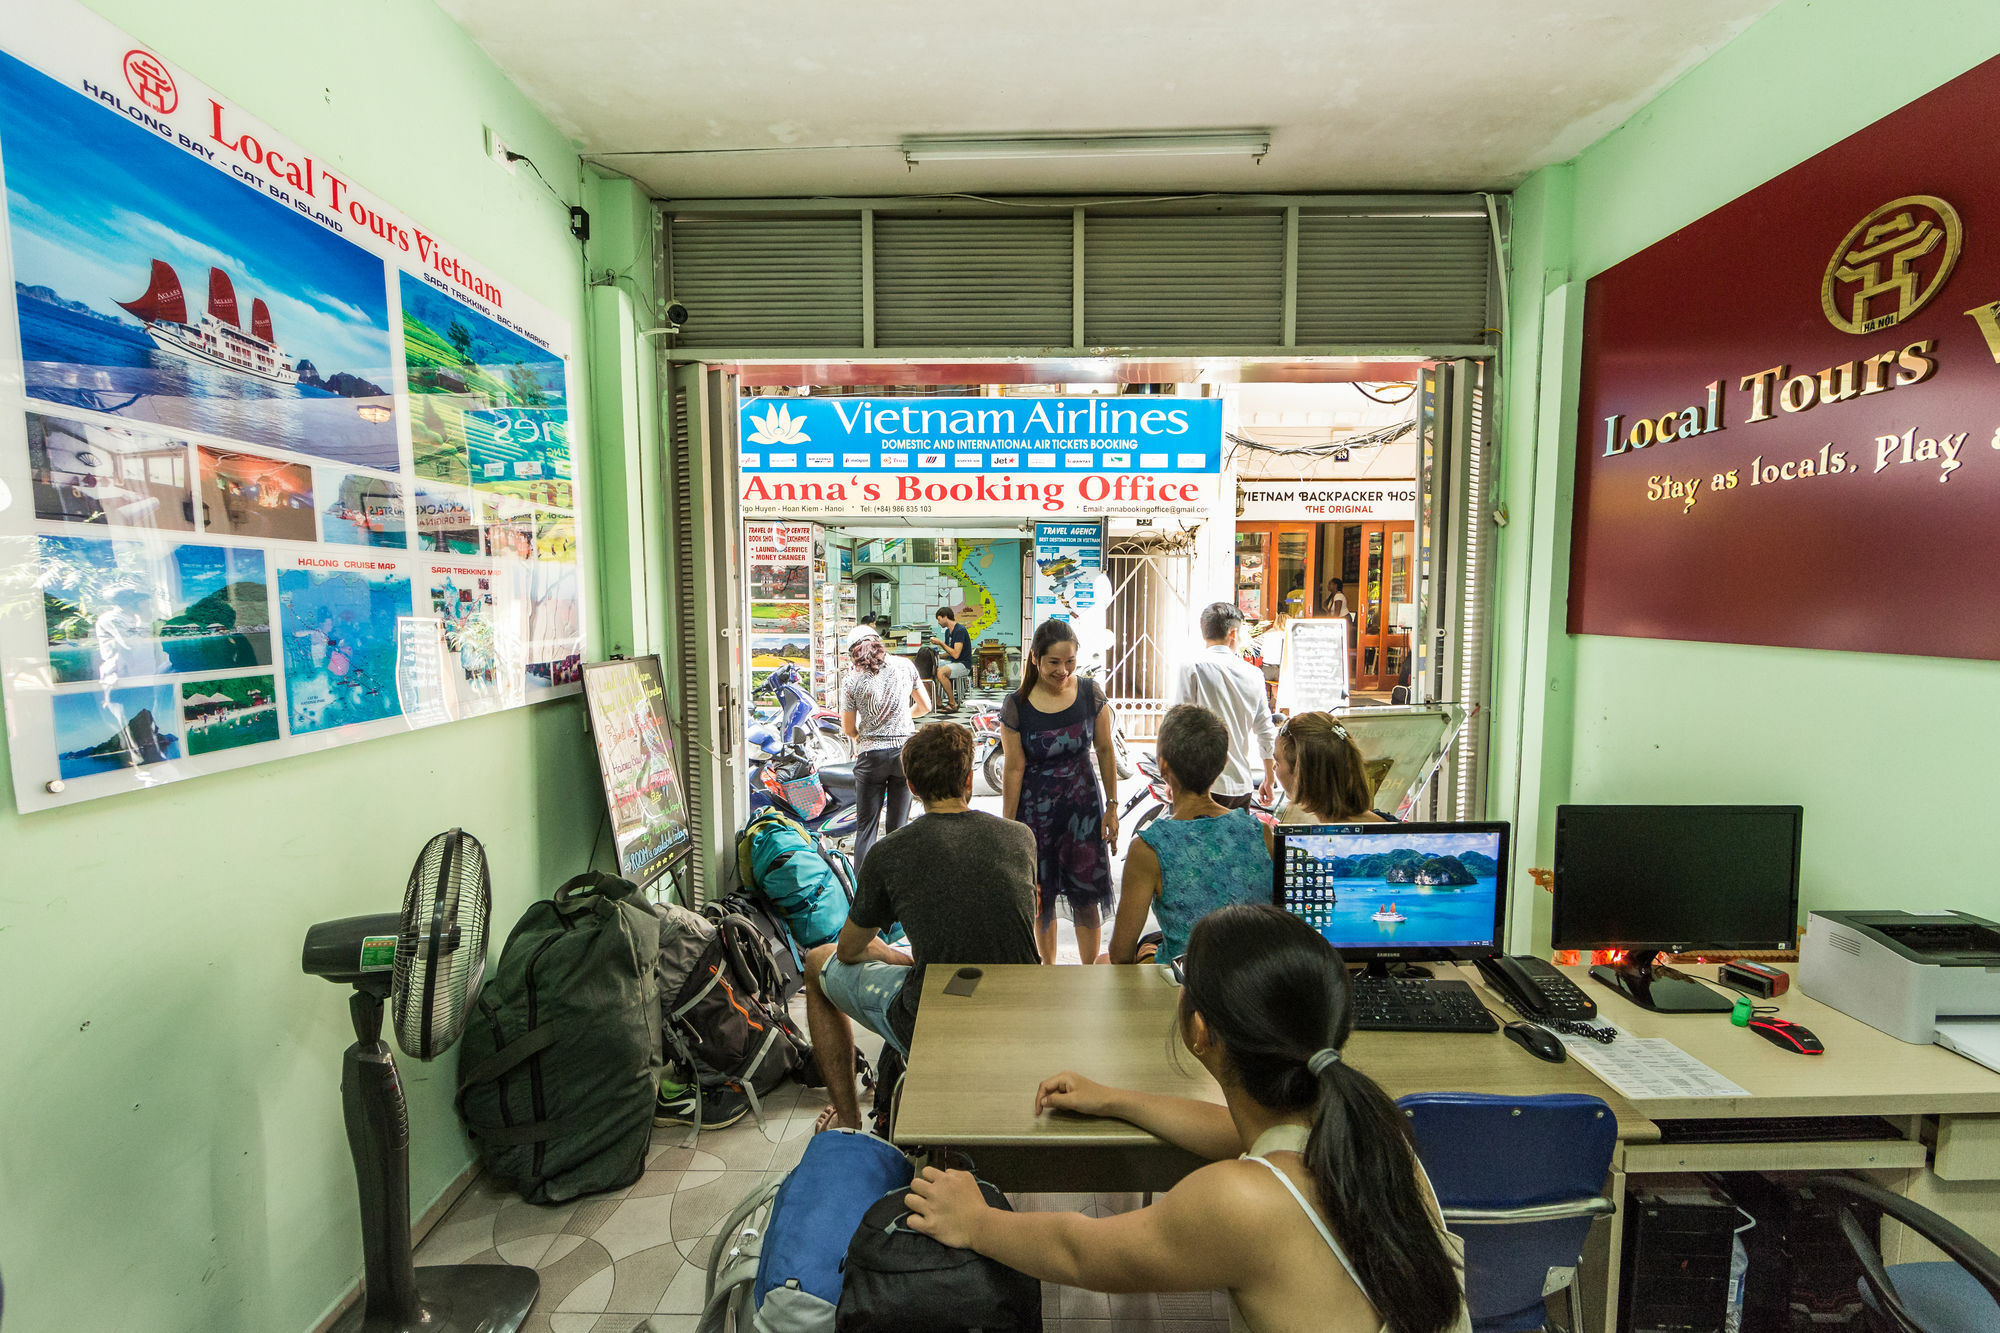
[0,0,650,1333]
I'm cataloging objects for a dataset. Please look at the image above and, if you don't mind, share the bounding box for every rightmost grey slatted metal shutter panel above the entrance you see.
[1298,212,1492,346]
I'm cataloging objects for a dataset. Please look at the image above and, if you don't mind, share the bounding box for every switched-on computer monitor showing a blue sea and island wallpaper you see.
[1272,823,1508,975]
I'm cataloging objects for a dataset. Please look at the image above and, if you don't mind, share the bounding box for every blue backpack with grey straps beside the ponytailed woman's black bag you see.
[700,1129,916,1333]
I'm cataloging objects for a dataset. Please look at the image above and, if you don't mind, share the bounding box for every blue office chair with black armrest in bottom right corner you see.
[1812,1175,2000,1333]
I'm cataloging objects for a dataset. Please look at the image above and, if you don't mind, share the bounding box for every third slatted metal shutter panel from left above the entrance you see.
[1084,212,1284,346]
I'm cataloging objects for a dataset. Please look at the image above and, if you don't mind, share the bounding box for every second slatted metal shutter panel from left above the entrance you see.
[874,214,1074,346]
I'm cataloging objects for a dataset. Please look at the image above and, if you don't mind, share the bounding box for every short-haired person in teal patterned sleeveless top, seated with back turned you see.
[1110,705,1270,963]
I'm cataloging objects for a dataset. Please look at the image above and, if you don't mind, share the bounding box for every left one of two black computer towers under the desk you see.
[1618,1175,1742,1333]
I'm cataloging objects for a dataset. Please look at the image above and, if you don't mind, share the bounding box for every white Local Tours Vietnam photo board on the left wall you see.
[0,0,584,811]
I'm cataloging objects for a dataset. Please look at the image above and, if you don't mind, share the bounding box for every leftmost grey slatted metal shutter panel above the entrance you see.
[670,216,862,348]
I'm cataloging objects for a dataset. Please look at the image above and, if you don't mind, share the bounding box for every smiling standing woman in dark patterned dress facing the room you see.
[1000,620,1118,963]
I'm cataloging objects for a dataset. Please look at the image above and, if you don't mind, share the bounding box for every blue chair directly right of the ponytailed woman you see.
[1396,1093,1618,1333]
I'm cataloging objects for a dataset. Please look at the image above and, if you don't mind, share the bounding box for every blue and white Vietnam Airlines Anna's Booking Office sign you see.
[740,396,1222,518]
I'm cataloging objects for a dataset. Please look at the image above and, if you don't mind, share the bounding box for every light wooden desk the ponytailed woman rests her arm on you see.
[896,965,1660,1193]
